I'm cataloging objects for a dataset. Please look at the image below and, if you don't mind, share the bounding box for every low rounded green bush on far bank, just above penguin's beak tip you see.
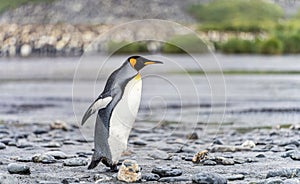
[161,34,208,53]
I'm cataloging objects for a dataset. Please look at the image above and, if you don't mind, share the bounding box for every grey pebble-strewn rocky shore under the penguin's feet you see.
[0,121,300,184]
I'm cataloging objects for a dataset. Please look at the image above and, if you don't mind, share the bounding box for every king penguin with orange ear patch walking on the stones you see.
[81,56,162,170]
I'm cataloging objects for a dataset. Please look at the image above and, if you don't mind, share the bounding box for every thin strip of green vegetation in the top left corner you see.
[0,0,55,13]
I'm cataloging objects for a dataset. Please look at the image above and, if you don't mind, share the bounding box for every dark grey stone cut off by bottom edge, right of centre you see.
[192,172,227,184]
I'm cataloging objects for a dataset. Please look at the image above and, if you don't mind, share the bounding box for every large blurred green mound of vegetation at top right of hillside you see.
[188,0,283,32]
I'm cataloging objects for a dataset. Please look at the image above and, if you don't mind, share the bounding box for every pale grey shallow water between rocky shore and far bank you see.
[0,55,300,127]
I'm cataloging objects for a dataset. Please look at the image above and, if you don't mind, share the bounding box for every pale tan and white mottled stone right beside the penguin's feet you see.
[117,160,142,183]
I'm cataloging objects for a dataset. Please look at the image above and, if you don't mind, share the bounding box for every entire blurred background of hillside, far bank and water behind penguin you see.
[0,0,300,132]
